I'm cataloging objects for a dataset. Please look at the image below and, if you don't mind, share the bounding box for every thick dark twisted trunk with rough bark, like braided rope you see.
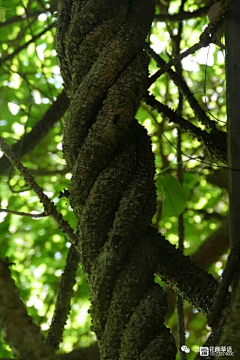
[56,0,176,360]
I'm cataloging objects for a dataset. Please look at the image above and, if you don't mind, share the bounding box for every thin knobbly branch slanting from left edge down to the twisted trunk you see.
[0,138,78,245]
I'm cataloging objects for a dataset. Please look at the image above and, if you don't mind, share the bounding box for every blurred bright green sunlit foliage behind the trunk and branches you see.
[0,0,228,359]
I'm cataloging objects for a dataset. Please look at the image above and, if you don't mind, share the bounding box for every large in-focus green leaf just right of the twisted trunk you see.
[156,174,187,216]
